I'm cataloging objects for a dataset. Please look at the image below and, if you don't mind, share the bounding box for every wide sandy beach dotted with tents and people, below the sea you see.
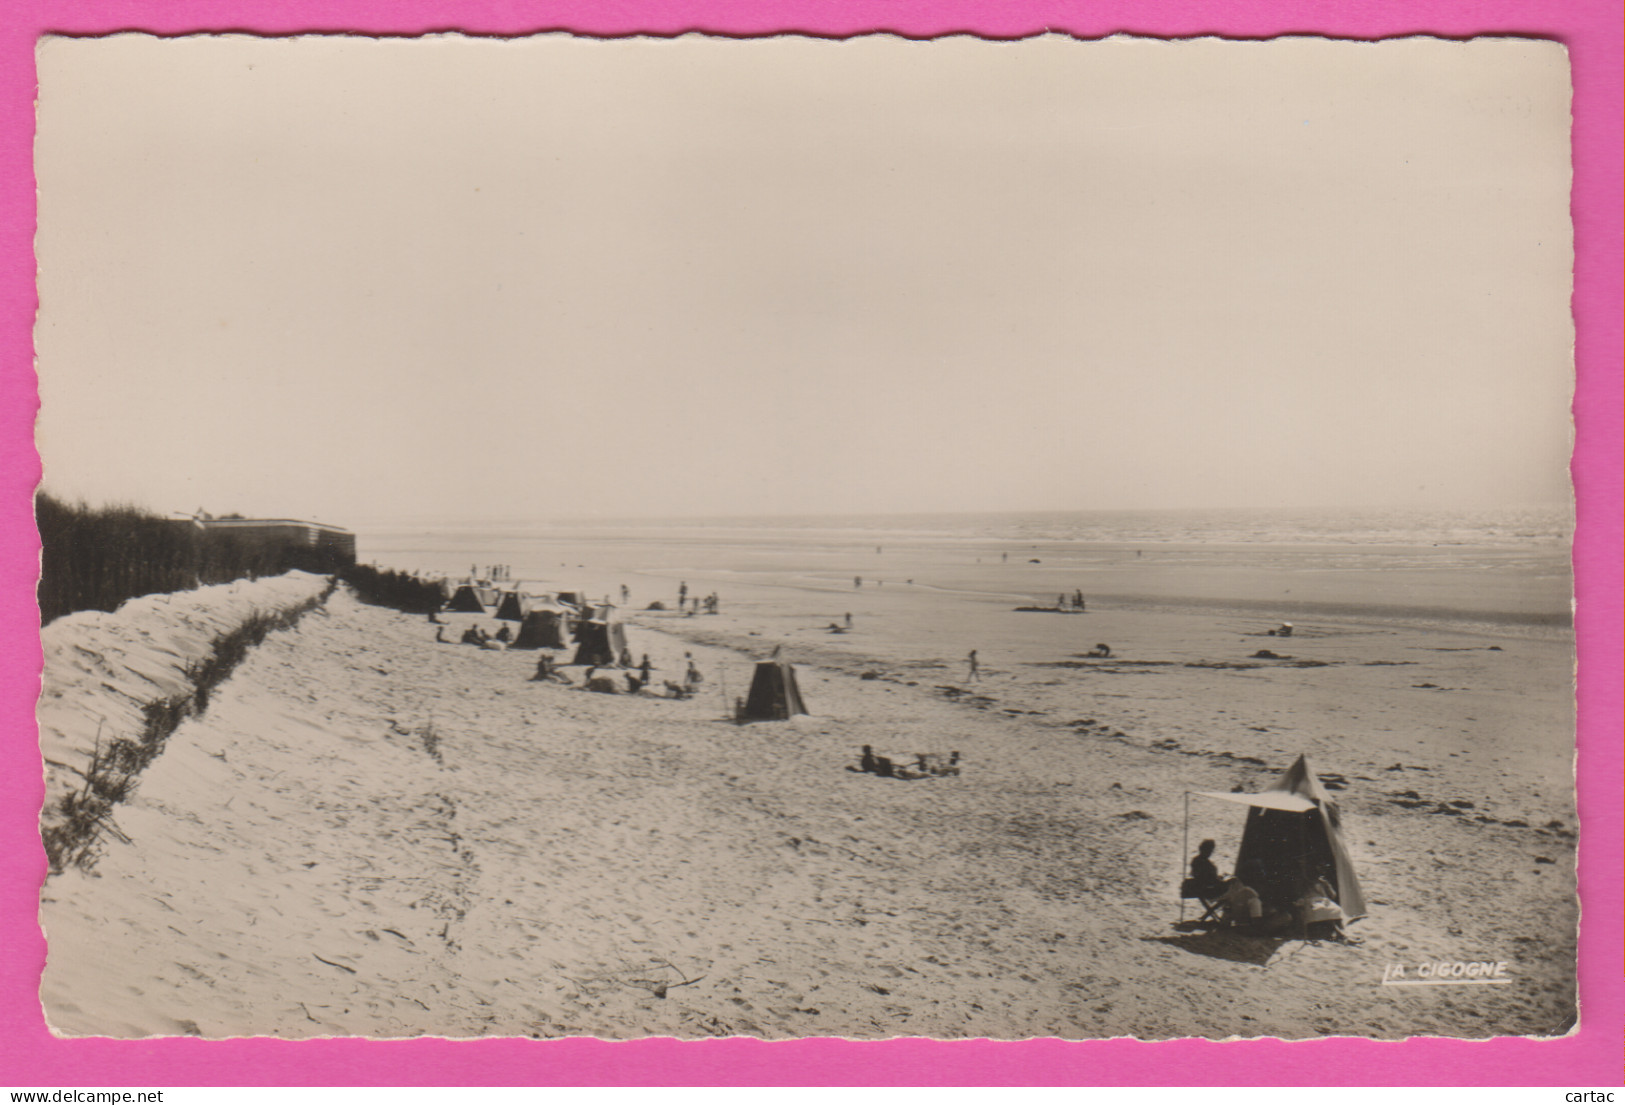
[42,529,1578,1038]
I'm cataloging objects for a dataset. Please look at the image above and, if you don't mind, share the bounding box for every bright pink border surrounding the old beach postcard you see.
[0,0,1625,1089]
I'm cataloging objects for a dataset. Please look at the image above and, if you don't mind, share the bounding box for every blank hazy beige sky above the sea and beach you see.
[37,36,1571,523]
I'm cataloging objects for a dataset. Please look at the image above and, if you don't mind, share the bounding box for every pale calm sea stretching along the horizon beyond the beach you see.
[356,505,1575,631]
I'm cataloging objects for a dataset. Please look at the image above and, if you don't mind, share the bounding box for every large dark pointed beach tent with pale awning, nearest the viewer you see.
[1198,756,1365,921]
